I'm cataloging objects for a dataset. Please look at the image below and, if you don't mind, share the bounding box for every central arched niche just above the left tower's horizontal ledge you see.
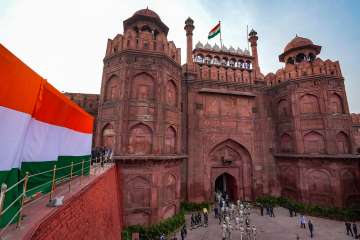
[129,124,152,155]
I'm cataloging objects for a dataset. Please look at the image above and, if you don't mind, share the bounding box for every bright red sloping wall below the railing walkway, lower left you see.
[28,166,122,240]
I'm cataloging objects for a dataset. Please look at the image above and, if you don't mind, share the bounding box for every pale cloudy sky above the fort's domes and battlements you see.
[0,0,360,113]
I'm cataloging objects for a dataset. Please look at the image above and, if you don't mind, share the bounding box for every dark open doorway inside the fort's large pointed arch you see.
[215,173,239,201]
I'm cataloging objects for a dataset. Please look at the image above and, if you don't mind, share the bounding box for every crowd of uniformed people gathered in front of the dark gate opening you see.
[214,192,256,240]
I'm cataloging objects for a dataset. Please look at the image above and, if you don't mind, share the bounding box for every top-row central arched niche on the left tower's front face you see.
[132,73,155,101]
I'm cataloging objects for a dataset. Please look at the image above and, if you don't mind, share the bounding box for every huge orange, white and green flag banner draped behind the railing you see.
[0,44,93,226]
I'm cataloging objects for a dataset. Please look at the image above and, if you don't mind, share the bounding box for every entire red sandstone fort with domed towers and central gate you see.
[67,9,360,225]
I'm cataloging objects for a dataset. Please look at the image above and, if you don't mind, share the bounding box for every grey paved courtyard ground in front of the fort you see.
[177,208,360,240]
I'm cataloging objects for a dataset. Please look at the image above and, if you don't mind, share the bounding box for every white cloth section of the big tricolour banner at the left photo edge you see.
[0,106,31,171]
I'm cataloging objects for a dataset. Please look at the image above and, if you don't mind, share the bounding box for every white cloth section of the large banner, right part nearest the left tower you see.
[22,119,92,162]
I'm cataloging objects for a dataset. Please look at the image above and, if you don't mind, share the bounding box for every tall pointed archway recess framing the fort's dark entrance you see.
[207,139,253,200]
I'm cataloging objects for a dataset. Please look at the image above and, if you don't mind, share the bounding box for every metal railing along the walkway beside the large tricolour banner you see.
[0,156,113,237]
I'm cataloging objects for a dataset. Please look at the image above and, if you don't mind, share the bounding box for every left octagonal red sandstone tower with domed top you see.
[97,9,183,225]
